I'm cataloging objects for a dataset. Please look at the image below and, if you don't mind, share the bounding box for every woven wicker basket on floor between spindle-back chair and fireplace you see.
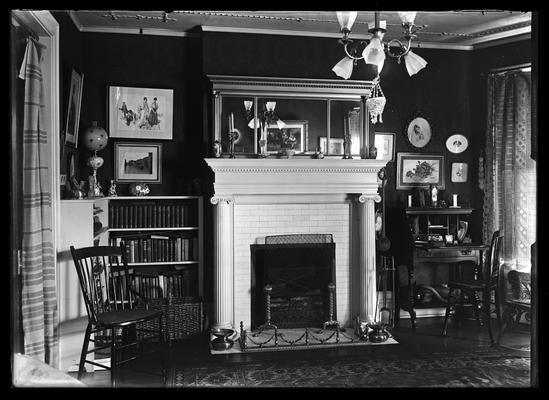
[137,297,204,341]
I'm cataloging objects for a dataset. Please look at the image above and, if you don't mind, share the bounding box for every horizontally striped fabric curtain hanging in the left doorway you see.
[19,39,58,367]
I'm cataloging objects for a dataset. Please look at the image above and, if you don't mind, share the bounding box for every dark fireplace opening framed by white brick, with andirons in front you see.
[250,234,336,329]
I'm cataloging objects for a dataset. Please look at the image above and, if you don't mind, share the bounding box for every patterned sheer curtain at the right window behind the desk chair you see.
[483,71,537,270]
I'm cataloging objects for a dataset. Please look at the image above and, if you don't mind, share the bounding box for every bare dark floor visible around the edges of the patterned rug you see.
[71,317,530,388]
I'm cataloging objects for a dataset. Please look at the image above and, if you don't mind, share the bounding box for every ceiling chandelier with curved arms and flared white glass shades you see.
[332,11,427,79]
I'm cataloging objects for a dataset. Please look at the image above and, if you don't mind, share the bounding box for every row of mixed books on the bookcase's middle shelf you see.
[110,234,198,263]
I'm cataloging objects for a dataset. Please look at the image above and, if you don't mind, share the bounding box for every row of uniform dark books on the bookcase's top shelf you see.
[109,201,198,228]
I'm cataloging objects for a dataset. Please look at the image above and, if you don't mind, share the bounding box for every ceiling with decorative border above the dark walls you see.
[67,10,532,50]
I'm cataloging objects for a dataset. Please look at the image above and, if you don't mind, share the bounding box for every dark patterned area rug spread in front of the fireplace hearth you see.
[168,348,530,388]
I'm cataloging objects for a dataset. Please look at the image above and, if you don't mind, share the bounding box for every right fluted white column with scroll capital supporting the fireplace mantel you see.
[358,194,381,323]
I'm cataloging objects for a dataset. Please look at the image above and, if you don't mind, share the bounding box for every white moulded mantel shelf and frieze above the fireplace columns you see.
[205,158,387,197]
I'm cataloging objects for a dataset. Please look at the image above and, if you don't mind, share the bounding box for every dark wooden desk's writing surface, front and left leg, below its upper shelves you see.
[405,242,490,329]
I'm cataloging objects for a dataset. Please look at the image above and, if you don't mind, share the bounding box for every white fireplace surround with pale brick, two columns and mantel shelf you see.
[205,158,386,330]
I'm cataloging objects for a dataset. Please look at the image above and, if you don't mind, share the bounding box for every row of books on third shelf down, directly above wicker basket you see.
[133,268,198,299]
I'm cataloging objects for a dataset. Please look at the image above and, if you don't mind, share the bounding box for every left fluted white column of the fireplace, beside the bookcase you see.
[210,196,234,328]
